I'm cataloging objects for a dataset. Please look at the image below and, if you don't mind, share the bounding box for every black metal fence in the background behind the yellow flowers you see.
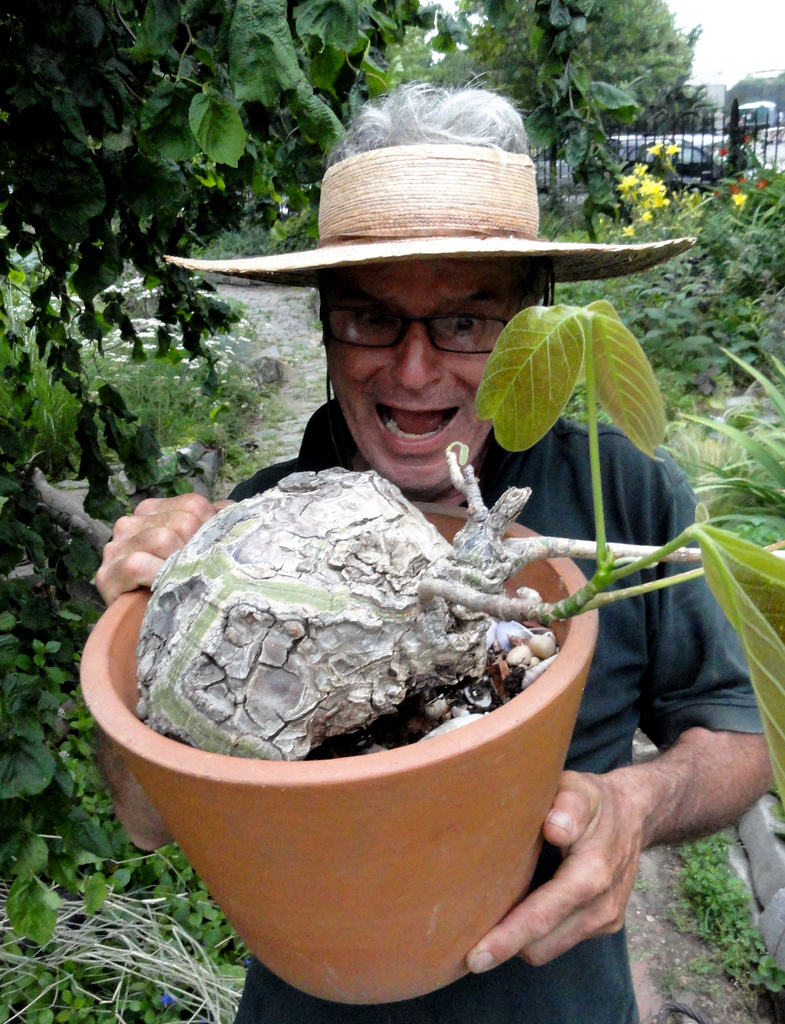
[532,109,785,191]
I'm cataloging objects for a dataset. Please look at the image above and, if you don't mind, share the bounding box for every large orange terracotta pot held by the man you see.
[82,510,597,1002]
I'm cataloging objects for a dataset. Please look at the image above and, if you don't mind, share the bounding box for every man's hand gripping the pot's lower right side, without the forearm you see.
[469,771,643,972]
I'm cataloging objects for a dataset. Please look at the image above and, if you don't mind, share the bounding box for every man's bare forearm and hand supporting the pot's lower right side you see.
[467,727,773,973]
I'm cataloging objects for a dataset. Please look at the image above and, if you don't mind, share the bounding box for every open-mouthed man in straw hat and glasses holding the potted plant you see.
[98,86,771,1024]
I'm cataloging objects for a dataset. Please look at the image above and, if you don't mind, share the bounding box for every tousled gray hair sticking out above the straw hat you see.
[328,82,529,167]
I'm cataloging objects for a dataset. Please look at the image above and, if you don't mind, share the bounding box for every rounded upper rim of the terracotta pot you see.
[82,505,598,788]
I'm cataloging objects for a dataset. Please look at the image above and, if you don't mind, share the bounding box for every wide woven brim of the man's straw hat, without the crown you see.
[166,237,696,287]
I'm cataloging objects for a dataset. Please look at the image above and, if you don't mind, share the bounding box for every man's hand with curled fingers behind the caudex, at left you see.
[95,494,232,605]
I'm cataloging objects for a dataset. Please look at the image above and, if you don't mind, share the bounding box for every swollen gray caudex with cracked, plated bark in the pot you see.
[138,453,529,760]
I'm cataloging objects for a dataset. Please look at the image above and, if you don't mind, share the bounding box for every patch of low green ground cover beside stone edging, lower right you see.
[680,833,785,992]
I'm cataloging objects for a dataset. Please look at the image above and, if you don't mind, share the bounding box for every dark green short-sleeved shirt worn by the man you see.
[231,406,762,1024]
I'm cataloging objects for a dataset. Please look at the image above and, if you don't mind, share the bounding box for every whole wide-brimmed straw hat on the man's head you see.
[167,144,695,286]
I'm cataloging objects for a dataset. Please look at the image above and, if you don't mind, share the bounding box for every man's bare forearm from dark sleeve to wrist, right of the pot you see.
[606,728,773,849]
